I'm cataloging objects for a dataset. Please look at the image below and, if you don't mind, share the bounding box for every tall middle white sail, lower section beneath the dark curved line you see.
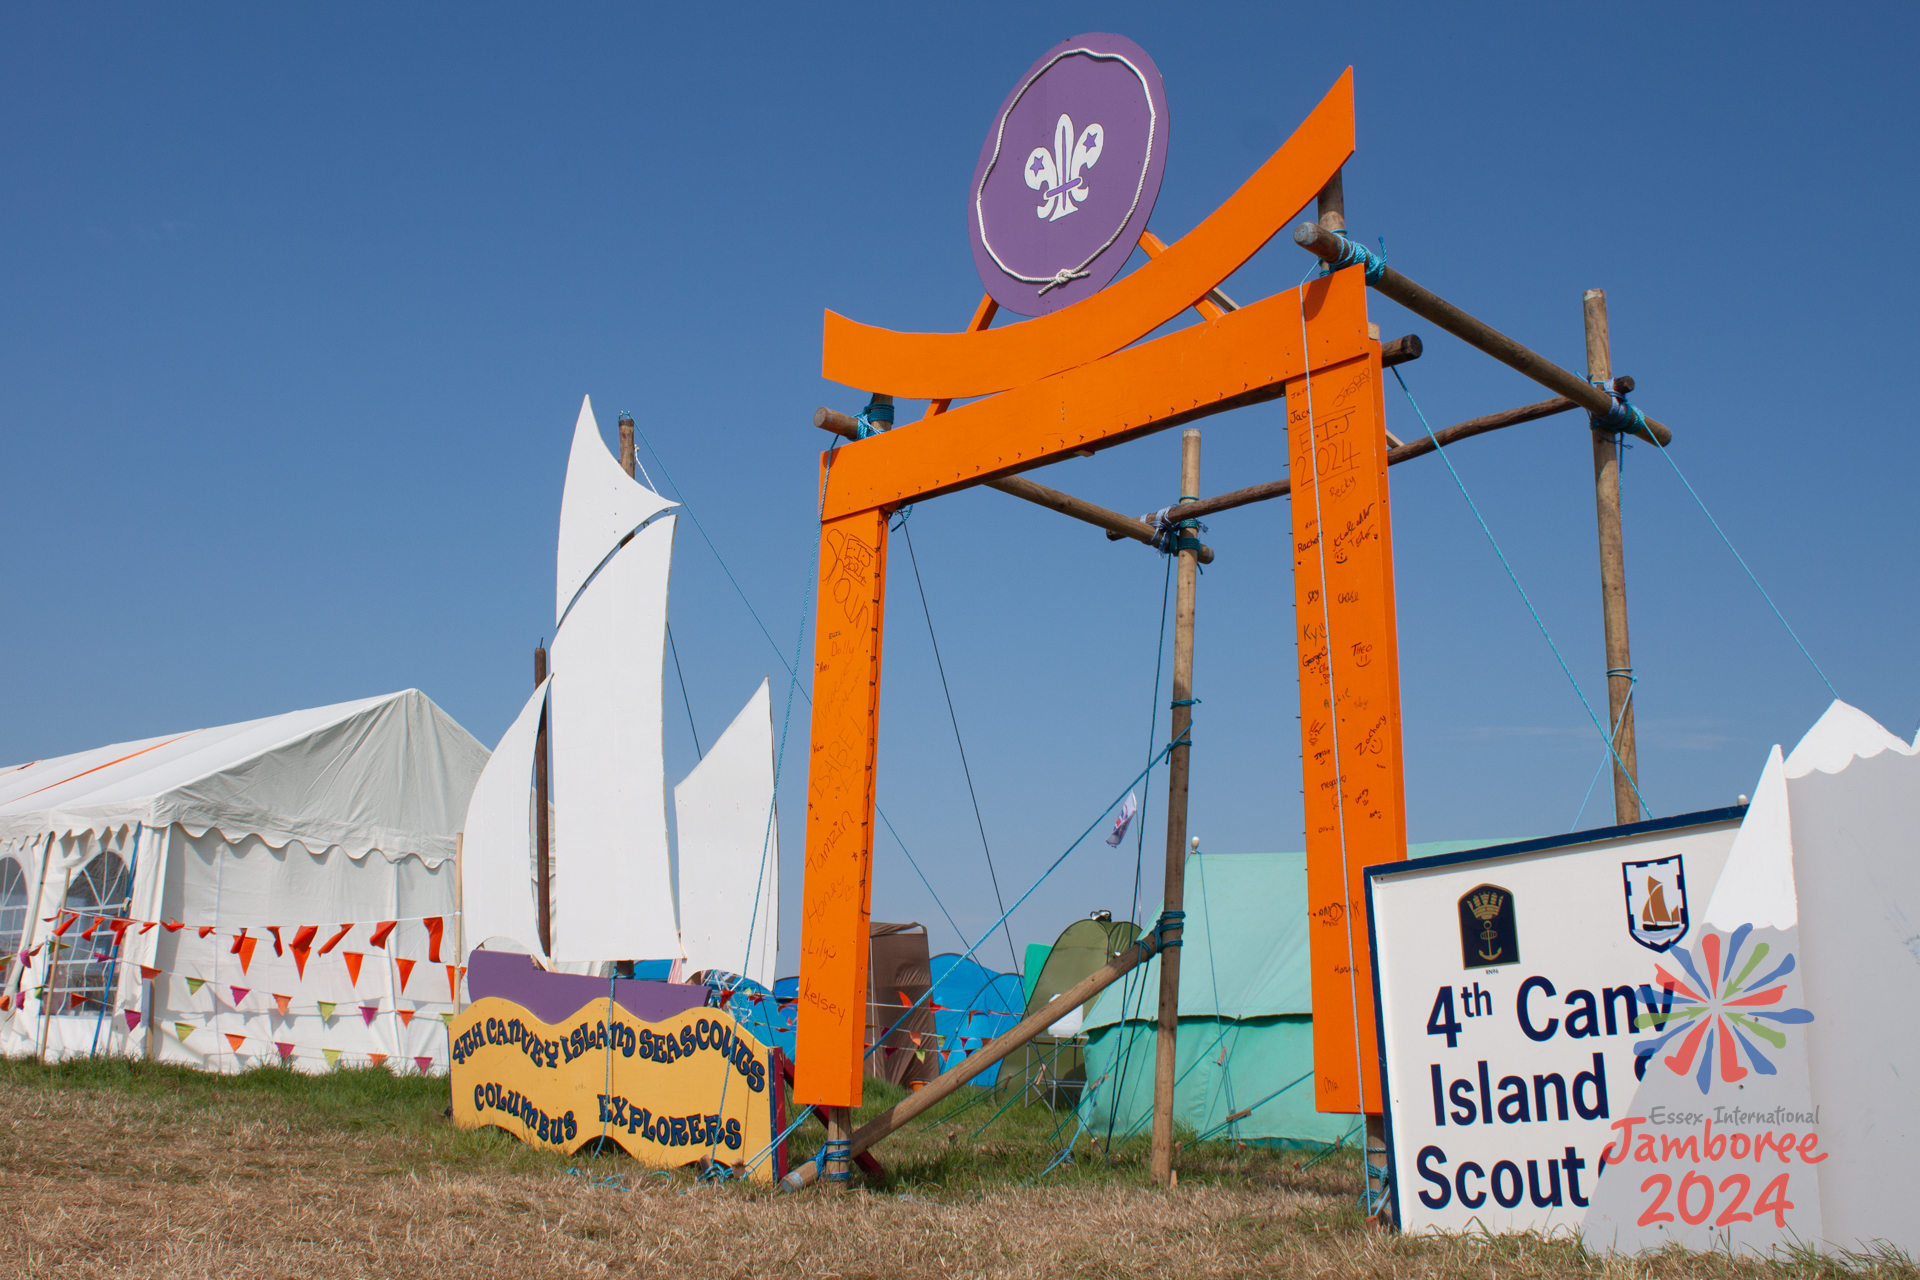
[549,514,680,961]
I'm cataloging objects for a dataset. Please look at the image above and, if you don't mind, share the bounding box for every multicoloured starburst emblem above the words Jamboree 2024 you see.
[1634,925,1812,1094]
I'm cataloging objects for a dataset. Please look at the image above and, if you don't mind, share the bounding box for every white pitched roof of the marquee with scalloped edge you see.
[0,689,488,864]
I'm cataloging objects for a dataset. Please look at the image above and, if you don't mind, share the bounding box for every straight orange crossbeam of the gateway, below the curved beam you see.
[826,270,1379,518]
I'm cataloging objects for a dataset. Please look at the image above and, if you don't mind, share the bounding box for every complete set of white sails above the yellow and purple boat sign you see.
[463,399,780,974]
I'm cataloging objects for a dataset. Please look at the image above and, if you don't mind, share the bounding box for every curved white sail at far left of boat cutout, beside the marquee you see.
[461,683,547,956]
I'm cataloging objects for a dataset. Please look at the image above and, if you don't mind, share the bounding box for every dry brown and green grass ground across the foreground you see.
[0,1059,1920,1280]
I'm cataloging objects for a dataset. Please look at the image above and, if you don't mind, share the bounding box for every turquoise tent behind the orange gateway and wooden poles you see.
[1081,841,1496,1146]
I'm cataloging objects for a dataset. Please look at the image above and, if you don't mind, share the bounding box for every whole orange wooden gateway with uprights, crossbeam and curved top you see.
[795,71,1405,1111]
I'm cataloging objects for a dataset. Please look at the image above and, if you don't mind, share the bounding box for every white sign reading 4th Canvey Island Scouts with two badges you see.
[1367,808,1743,1232]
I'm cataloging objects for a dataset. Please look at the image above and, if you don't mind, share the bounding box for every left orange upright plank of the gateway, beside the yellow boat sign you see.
[793,498,887,1107]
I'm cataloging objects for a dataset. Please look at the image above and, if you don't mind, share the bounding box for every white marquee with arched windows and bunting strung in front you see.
[0,689,488,1071]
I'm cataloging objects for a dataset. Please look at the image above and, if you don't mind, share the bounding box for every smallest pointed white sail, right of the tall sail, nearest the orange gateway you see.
[674,679,780,990]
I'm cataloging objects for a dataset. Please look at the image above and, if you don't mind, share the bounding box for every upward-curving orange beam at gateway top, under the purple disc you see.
[820,67,1354,399]
